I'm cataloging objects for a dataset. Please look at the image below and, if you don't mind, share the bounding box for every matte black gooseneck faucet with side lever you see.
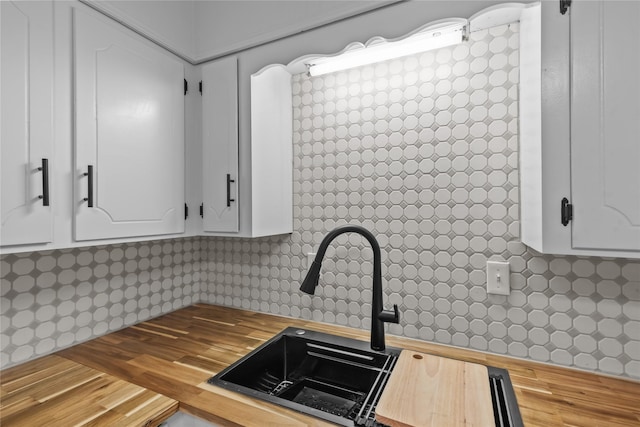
[300,225,400,351]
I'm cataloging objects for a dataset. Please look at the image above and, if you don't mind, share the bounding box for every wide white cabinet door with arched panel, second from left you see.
[73,9,185,240]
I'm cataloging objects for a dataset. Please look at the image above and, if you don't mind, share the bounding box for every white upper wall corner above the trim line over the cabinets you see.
[80,0,398,63]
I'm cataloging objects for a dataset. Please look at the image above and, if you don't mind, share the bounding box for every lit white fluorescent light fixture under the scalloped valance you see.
[308,23,466,76]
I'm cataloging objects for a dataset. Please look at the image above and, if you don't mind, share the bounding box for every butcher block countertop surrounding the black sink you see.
[0,304,640,427]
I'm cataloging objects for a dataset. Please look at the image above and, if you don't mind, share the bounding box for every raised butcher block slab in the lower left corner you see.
[0,355,178,427]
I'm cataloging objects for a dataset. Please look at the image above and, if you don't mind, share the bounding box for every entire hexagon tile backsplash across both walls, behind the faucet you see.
[0,25,640,379]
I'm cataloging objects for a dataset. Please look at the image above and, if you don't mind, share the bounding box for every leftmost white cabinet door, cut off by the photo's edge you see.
[0,1,54,246]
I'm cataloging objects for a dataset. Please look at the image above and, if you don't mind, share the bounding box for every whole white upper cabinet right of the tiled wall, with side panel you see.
[520,1,640,258]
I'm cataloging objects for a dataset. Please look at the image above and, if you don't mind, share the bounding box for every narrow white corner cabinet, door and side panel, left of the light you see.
[201,61,293,237]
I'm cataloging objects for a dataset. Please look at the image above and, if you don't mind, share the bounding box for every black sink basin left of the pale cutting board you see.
[208,328,400,426]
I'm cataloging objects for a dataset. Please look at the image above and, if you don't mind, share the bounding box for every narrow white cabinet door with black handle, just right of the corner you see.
[202,57,238,232]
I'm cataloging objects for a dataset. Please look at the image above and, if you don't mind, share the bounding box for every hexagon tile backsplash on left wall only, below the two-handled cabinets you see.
[0,239,202,368]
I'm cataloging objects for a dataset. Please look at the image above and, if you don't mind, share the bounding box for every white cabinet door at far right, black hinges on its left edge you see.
[571,1,640,252]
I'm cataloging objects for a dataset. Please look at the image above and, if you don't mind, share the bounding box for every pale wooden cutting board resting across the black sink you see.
[376,350,494,427]
